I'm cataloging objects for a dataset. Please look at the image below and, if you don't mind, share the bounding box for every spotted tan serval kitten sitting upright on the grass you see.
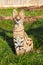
[13,10,33,55]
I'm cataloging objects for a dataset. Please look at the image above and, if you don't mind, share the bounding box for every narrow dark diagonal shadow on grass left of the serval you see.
[0,28,16,54]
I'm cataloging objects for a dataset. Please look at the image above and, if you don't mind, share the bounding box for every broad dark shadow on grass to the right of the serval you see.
[26,26,43,48]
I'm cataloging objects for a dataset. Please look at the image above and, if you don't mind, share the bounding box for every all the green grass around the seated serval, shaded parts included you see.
[0,9,43,65]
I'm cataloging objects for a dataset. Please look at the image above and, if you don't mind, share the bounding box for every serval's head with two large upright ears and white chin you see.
[13,10,25,24]
